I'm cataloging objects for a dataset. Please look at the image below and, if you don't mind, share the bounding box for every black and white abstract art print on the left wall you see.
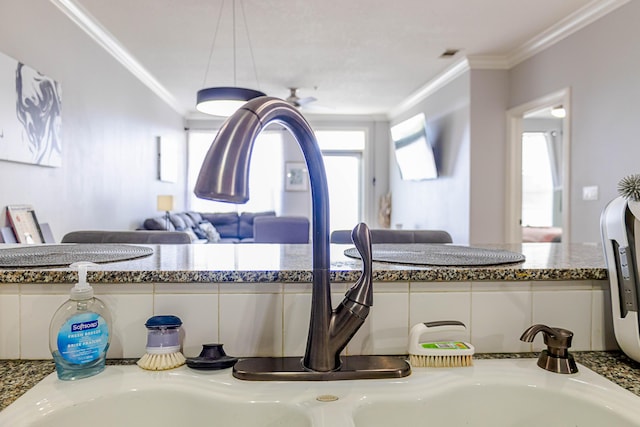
[0,53,62,167]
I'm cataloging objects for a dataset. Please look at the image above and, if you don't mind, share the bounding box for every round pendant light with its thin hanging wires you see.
[196,0,266,117]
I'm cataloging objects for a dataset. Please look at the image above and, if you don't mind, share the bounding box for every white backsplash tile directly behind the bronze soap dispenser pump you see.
[532,290,592,351]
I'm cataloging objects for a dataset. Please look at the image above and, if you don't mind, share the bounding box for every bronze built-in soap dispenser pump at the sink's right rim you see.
[520,324,578,374]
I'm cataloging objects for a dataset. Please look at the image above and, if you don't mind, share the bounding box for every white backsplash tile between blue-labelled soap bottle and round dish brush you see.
[98,294,153,359]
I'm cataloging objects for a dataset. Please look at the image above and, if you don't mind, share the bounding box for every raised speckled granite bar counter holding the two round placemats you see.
[0,243,607,285]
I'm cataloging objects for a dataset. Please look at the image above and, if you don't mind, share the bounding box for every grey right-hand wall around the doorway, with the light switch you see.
[509,1,640,242]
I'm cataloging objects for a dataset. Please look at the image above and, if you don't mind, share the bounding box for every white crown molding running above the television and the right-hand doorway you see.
[388,0,630,118]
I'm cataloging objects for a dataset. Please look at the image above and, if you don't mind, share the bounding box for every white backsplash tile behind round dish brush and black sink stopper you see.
[153,293,219,357]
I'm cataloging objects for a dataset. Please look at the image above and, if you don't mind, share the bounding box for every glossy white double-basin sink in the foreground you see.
[0,359,640,427]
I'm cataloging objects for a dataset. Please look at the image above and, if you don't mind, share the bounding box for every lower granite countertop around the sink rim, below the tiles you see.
[0,351,640,410]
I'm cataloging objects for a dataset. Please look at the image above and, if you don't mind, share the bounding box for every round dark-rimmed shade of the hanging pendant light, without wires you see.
[196,87,266,117]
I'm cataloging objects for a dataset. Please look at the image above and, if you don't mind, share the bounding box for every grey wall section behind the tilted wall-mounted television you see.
[387,72,472,244]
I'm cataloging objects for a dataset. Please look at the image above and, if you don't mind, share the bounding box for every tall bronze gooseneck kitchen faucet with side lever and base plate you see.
[194,97,411,380]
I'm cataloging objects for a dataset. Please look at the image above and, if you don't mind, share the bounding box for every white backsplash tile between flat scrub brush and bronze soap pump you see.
[471,290,531,353]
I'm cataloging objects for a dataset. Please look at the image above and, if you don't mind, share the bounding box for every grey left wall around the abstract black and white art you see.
[0,0,186,241]
